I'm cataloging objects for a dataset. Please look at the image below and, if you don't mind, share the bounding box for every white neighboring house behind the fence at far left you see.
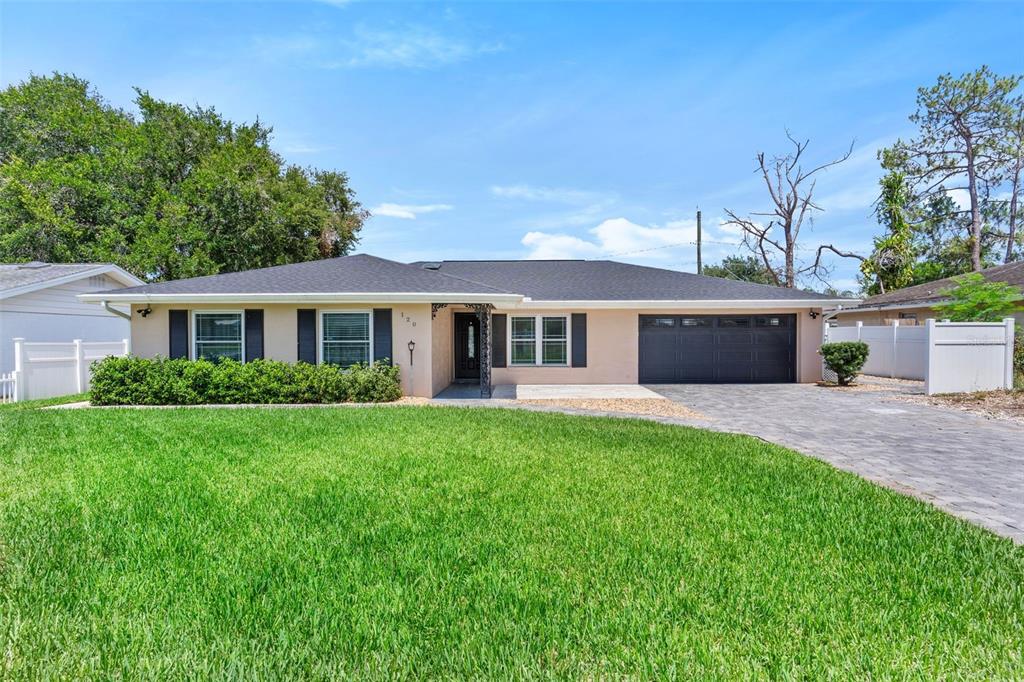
[0,262,143,373]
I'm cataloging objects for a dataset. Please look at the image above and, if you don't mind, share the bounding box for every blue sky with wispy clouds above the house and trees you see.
[0,2,1024,287]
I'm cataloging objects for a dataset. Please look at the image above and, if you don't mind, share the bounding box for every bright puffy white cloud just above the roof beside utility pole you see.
[522,218,739,265]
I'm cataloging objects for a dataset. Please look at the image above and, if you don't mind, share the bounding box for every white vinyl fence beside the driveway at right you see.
[825,317,1014,395]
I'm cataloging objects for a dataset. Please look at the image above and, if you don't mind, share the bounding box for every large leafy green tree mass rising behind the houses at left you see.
[0,74,367,281]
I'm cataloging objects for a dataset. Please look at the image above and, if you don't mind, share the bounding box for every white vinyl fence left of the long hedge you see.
[0,339,131,402]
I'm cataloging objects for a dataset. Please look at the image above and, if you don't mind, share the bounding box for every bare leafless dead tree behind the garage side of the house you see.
[725,130,853,289]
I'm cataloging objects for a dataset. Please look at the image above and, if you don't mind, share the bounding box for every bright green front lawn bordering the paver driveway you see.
[0,408,1024,679]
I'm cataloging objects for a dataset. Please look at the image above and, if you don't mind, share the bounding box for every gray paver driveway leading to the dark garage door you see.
[649,384,1024,543]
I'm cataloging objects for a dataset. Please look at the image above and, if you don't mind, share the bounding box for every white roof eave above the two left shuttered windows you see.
[78,292,522,304]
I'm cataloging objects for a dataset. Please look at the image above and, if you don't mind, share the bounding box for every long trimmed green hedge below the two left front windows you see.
[89,357,401,404]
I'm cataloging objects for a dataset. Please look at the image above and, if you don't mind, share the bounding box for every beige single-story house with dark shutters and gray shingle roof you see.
[80,255,849,396]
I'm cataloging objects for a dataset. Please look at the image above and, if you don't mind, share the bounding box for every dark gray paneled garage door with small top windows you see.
[640,314,797,384]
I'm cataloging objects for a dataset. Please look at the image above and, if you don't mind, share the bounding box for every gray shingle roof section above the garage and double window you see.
[415,260,835,301]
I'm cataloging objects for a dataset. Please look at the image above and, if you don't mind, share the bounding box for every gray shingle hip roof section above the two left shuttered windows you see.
[115,254,509,295]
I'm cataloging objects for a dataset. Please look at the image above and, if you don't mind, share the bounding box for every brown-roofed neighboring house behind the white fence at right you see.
[830,261,1024,327]
